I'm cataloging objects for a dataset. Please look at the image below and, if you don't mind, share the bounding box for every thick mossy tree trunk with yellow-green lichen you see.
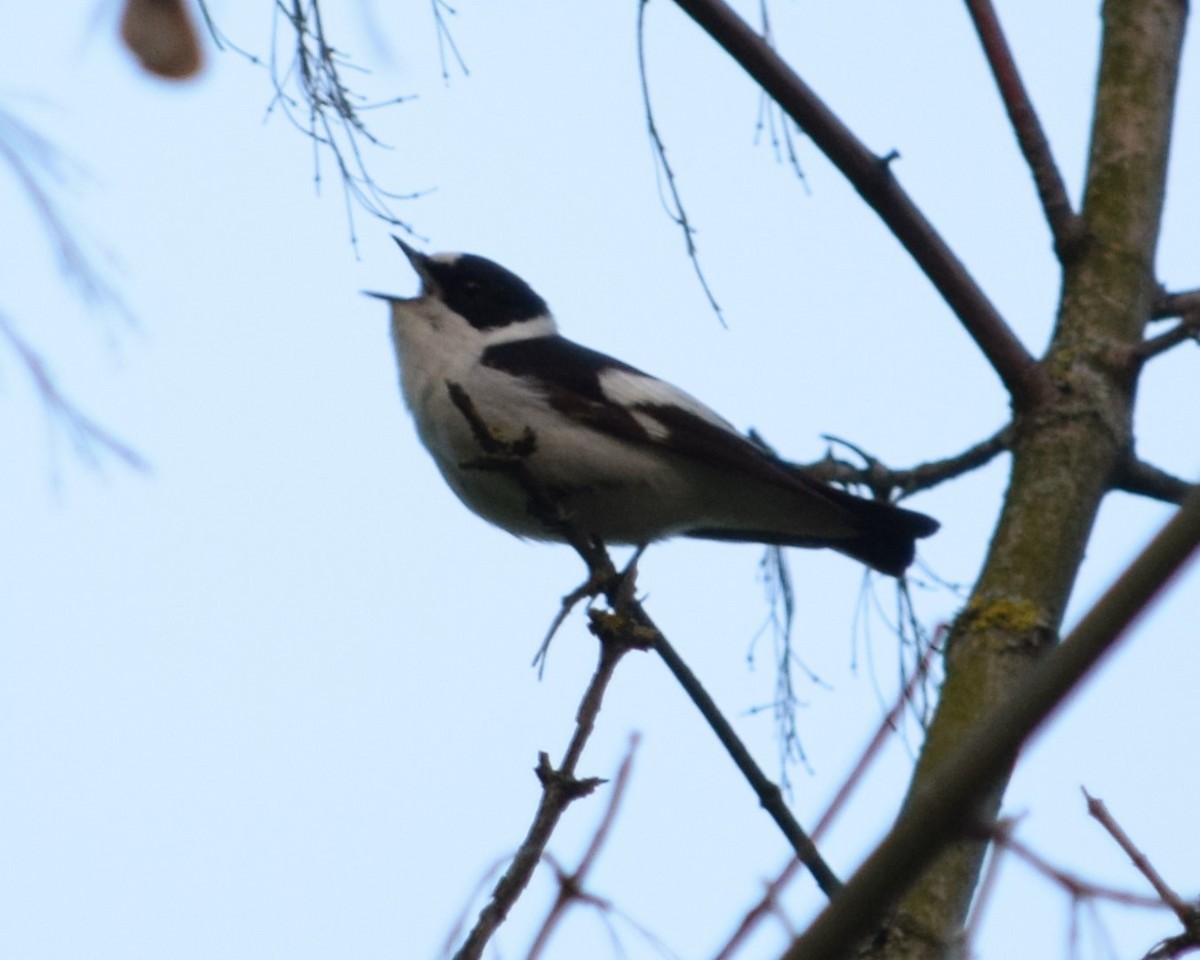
[864,0,1187,959]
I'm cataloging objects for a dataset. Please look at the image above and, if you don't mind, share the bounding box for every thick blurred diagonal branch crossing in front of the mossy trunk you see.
[784,475,1200,960]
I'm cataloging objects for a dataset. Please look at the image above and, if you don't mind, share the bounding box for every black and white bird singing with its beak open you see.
[372,238,938,576]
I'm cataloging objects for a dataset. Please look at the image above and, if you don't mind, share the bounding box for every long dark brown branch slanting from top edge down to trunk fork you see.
[676,0,1051,410]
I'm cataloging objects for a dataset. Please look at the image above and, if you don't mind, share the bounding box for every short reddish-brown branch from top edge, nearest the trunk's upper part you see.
[966,0,1082,263]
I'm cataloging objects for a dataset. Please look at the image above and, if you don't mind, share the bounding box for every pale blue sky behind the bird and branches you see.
[0,0,1200,960]
